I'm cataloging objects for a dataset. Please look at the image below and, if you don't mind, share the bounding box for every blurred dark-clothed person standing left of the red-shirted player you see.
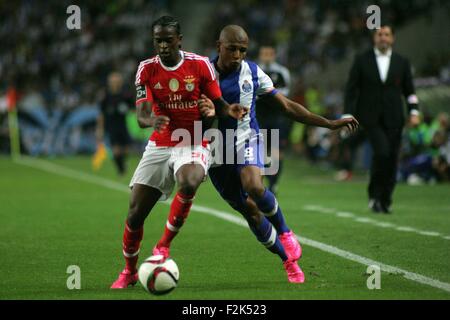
[96,72,134,176]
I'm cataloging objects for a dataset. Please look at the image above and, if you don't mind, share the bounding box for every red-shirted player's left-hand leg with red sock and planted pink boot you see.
[111,184,161,289]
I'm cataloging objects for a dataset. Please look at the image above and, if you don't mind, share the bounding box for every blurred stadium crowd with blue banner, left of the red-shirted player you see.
[0,0,170,155]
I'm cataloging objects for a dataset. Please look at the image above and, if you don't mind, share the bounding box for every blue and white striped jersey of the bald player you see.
[213,58,277,146]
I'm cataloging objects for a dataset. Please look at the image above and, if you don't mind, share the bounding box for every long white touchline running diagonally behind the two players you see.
[14,157,450,292]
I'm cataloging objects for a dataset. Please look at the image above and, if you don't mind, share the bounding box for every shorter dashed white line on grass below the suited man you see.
[303,205,450,240]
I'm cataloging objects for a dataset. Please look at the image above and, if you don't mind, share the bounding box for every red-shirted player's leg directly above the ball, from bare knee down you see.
[153,163,205,257]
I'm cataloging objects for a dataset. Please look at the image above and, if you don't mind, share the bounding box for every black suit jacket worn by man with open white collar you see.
[345,49,417,128]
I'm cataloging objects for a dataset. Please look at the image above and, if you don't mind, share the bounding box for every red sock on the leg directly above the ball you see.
[157,192,194,247]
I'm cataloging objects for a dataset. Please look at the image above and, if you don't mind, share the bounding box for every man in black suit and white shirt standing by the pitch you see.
[345,25,419,213]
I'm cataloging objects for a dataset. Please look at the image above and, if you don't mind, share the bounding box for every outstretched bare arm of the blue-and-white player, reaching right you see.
[264,92,359,132]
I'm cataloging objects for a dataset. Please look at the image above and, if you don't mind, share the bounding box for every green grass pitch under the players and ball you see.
[0,157,450,300]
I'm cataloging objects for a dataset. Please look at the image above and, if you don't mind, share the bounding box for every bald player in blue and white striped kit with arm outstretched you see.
[202,25,358,283]
